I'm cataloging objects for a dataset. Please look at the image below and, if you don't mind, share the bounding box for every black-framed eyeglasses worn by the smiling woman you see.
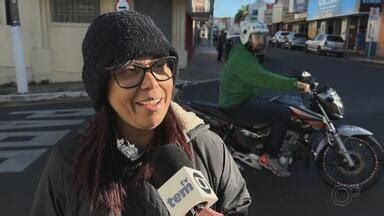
[112,56,176,89]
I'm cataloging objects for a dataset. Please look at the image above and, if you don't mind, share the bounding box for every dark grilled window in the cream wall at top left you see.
[51,0,100,23]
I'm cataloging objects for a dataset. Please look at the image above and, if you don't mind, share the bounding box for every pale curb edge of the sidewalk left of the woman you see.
[0,91,88,102]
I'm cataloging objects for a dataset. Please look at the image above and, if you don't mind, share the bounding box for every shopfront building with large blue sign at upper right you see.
[307,0,381,53]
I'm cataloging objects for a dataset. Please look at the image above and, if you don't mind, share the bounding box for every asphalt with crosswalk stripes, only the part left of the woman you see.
[0,100,93,216]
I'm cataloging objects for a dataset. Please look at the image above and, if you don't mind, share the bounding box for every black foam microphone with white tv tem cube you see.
[152,144,218,216]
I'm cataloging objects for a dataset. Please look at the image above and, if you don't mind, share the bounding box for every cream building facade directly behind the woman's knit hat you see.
[0,0,213,84]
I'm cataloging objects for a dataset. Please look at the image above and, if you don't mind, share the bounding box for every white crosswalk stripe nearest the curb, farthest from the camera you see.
[9,108,95,119]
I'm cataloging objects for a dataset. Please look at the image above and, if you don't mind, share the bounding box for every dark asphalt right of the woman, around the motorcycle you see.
[182,48,384,216]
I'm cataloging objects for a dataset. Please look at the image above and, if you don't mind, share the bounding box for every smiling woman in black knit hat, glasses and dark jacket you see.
[32,11,250,216]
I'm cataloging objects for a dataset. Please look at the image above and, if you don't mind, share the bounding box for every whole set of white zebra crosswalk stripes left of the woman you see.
[0,108,94,173]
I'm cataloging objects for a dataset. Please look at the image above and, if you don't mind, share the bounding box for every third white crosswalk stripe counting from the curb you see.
[0,130,70,148]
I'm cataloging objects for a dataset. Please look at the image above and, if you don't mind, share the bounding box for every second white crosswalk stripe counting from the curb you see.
[0,119,84,130]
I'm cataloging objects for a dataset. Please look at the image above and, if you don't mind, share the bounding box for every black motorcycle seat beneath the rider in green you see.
[191,100,270,129]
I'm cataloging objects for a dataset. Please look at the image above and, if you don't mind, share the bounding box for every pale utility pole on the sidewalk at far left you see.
[5,0,28,94]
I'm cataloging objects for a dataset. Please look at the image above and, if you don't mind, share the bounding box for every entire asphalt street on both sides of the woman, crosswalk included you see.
[0,49,384,216]
